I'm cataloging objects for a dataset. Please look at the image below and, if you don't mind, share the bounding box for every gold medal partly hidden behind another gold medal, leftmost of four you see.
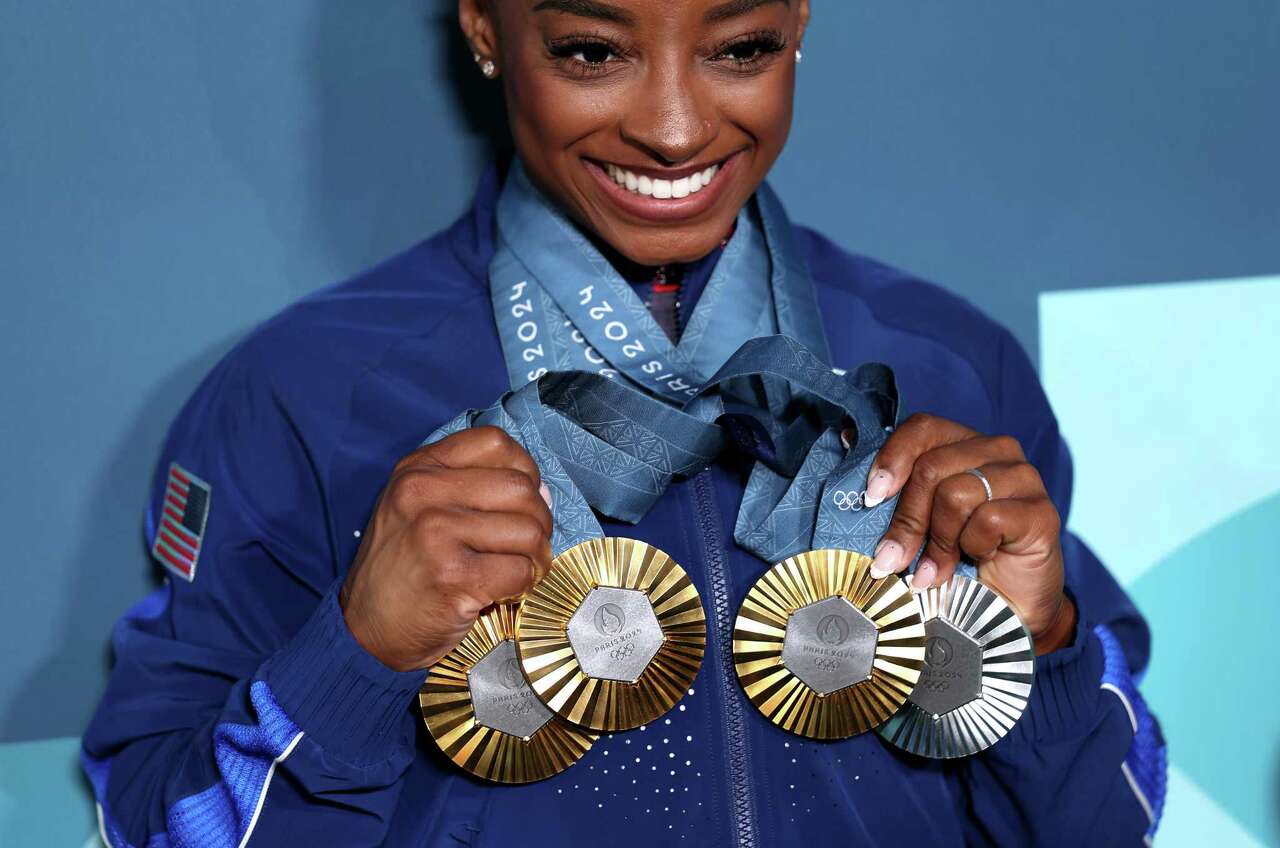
[417,605,596,784]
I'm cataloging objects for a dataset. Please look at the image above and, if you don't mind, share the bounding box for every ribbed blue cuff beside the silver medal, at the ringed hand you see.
[1009,596,1105,746]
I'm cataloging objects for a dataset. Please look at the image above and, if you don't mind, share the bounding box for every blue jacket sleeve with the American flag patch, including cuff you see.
[82,347,425,848]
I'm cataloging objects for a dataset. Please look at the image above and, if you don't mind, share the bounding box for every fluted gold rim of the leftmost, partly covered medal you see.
[417,603,598,784]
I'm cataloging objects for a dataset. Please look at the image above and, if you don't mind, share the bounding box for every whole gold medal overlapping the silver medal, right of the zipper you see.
[733,548,924,739]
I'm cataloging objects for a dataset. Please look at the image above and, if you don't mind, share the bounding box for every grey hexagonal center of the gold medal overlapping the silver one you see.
[782,596,878,694]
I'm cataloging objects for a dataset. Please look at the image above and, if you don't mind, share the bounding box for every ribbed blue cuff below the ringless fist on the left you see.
[259,582,426,765]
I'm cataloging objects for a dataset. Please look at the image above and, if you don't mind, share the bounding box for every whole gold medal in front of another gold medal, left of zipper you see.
[516,537,707,731]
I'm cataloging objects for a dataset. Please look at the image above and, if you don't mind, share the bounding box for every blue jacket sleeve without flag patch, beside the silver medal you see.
[961,336,1166,845]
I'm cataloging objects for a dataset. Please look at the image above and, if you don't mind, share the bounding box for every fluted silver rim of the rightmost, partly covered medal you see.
[879,574,1036,760]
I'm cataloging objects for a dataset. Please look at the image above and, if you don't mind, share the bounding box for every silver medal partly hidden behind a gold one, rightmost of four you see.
[879,574,1036,760]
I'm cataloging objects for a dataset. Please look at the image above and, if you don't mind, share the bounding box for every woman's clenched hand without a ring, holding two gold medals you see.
[340,427,552,671]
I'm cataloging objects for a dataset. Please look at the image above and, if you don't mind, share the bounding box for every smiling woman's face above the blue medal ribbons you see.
[458,0,809,265]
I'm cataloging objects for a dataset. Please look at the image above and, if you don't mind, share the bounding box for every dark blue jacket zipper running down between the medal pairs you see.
[694,469,756,848]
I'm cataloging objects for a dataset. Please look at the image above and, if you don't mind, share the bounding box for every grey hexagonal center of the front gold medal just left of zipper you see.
[566,587,664,683]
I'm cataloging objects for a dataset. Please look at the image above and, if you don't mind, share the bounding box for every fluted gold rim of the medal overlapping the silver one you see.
[733,548,924,739]
